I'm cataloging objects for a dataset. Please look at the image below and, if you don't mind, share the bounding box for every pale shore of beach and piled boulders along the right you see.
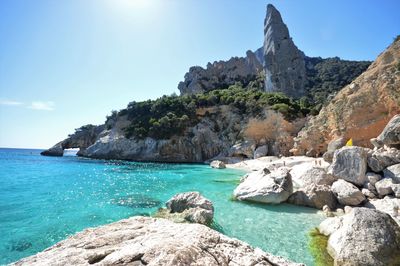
[212,115,400,265]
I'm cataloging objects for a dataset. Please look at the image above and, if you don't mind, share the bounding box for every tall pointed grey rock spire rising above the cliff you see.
[264,4,306,98]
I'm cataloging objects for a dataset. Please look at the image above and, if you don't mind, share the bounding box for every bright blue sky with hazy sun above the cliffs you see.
[0,0,400,148]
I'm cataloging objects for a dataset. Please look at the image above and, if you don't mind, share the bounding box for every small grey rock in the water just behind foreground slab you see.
[164,192,214,225]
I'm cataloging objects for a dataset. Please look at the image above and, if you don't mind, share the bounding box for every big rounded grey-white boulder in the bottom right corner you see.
[327,208,400,266]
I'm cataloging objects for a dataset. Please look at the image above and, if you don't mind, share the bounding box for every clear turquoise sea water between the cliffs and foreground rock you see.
[0,149,322,265]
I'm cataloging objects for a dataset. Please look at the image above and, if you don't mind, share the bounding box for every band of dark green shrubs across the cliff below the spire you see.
[112,83,310,139]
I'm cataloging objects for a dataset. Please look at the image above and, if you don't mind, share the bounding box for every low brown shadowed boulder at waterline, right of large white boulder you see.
[288,184,337,209]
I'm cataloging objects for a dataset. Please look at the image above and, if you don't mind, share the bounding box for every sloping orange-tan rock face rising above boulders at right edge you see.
[292,39,400,156]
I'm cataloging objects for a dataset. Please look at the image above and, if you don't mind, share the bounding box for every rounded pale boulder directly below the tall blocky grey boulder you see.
[332,179,365,206]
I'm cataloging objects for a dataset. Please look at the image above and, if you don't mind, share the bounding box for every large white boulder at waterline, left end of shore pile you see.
[233,167,293,203]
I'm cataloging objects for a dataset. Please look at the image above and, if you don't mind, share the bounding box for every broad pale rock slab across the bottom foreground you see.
[14,217,299,266]
